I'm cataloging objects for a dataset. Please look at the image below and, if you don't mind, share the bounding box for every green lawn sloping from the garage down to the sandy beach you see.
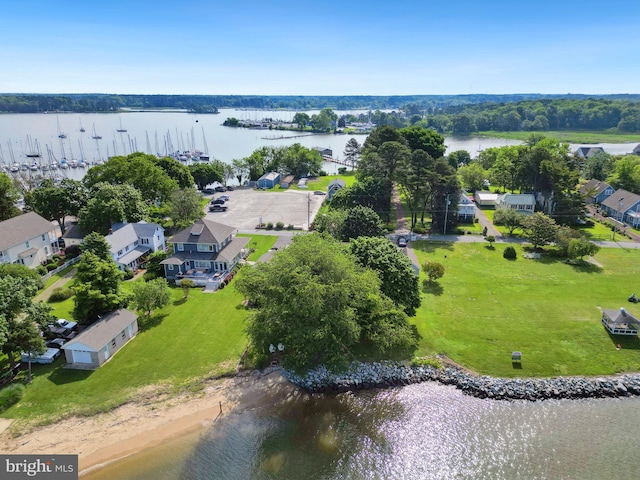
[2,273,251,422]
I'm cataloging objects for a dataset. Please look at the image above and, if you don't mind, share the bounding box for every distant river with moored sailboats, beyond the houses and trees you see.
[0,109,635,179]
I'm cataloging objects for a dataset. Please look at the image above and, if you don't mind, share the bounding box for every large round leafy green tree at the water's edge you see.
[236,234,416,370]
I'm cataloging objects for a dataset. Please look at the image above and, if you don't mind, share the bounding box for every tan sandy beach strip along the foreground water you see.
[0,371,293,475]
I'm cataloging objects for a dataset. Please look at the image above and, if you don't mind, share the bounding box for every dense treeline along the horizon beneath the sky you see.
[0,94,640,135]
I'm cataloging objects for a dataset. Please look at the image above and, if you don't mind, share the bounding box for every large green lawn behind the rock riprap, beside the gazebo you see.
[413,242,640,376]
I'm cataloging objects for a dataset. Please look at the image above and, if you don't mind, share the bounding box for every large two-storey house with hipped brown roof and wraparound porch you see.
[161,219,249,291]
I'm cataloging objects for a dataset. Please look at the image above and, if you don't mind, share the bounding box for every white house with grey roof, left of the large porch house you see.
[104,222,166,270]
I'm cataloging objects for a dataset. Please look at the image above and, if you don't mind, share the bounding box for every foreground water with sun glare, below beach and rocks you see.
[83,383,640,480]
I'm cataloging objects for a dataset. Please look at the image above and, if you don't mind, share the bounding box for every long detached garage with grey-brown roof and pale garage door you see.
[62,308,138,370]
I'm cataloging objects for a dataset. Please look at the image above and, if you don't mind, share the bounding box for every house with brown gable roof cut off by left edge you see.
[0,212,59,268]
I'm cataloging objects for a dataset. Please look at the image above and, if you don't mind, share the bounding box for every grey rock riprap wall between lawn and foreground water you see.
[283,362,640,401]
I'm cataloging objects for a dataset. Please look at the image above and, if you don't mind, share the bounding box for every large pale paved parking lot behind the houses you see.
[205,188,326,231]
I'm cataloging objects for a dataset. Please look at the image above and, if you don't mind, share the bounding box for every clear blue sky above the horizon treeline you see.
[0,0,640,95]
